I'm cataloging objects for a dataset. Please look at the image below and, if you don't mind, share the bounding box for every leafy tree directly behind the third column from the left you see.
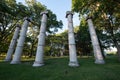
[22,0,62,57]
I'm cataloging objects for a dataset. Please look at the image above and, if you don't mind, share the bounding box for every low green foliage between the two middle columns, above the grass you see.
[45,32,68,56]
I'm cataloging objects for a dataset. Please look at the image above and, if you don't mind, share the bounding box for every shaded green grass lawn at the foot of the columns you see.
[0,57,120,80]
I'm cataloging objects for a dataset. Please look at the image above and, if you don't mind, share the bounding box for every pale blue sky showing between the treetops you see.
[16,0,80,33]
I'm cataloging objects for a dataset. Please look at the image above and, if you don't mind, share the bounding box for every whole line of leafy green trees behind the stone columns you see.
[0,0,120,57]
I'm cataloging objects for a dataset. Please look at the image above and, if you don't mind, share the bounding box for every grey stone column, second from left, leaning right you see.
[11,18,30,64]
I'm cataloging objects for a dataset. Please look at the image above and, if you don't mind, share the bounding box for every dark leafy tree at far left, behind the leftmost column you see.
[0,0,30,55]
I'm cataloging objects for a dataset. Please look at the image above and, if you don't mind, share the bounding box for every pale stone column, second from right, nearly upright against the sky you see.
[66,11,79,67]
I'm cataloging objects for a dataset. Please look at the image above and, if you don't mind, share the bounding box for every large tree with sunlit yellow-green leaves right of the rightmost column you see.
[72,0,120,59]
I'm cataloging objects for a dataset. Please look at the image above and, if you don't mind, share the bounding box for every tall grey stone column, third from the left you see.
[33,11,48,67]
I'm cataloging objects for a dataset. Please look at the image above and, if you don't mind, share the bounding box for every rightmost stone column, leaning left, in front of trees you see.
[86,17,105,64]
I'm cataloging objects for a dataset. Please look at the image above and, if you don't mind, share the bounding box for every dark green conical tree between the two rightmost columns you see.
[75,19,92,56]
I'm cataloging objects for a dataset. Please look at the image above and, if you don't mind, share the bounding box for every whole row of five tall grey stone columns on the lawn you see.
[5,11,105,67]
